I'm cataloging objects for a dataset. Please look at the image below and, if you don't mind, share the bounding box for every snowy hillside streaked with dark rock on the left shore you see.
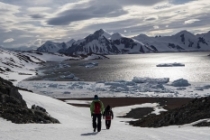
[0,48,73,85]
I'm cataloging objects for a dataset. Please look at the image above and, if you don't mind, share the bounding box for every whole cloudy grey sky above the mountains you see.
[0,0,210,47]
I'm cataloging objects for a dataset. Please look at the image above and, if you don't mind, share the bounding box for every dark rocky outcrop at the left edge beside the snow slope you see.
[0,77,59,124]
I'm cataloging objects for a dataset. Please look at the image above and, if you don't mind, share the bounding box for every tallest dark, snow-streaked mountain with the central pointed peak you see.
[59,29,155,55]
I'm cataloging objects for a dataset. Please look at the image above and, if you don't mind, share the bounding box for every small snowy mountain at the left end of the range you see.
[37,41,67,53]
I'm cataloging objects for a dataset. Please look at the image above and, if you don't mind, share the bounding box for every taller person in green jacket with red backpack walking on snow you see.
[90,95,104,132]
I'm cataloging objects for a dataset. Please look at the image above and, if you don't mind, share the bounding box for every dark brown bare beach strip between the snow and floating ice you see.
[59,97,194,119]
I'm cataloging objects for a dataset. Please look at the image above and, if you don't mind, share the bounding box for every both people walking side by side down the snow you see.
[90,95,114,132]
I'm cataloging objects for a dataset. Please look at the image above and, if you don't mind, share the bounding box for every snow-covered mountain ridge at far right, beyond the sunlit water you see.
[133,31,210,52]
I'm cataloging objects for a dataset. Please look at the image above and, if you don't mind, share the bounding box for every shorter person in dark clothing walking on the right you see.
[103,105,114,129]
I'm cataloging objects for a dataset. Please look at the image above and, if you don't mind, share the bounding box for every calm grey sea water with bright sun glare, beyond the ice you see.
[35,52,210,82]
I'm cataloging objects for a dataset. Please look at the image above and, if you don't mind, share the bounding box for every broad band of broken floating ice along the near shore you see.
[18,77,210,98]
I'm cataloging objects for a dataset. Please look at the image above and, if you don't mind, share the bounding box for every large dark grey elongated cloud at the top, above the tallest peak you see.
[47,0,166,25]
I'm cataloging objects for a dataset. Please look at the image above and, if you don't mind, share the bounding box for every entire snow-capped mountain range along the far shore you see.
[38,29,210,55]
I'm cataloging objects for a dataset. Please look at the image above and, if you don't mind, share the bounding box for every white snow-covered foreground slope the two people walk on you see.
[0,91,210,140]
